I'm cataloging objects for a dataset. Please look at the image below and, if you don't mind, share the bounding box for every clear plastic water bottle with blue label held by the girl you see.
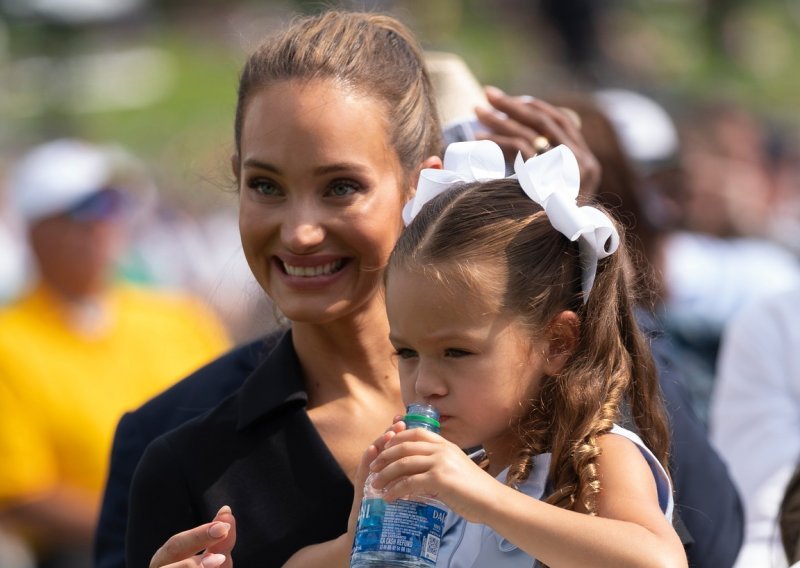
[350,404,447,568]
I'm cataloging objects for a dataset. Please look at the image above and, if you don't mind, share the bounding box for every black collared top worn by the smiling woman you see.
[126,332,354,568]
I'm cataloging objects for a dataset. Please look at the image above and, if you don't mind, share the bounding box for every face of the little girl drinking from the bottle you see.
[386,268,547,463]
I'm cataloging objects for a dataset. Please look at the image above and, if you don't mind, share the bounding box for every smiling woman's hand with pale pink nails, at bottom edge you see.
[150,505,236,568]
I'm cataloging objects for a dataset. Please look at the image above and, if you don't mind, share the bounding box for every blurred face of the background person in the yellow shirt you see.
[29,190,124,299]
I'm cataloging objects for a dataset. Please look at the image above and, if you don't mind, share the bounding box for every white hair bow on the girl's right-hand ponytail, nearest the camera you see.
[514,144,619,303]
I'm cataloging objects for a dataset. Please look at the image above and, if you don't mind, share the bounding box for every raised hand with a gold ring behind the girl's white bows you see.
[475,87,602,195]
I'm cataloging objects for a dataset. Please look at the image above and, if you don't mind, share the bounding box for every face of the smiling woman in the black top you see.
[234,80,409,323]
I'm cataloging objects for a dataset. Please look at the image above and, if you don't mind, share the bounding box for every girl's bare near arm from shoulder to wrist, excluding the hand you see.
[482,435,687,567]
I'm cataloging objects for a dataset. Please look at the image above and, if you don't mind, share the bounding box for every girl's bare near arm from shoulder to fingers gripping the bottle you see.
[374,430,687,568]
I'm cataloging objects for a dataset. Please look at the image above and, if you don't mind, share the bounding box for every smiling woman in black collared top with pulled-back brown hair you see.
[126,12,441,567]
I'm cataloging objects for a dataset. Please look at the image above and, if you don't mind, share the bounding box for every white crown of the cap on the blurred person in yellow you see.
[9,139,113,223]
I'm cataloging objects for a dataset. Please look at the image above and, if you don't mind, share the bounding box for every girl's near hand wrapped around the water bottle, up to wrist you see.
[371,428,498,522]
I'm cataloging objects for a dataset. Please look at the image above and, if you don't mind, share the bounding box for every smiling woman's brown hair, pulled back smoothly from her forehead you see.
[234,10,442,182]
